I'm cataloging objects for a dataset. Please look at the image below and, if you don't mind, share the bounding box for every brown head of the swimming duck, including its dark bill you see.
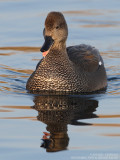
[40,12,68,56]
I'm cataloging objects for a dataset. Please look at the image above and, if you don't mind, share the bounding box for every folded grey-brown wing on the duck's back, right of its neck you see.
[67,44,103,72]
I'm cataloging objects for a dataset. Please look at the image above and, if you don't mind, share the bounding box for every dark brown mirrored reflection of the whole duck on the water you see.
[33,95,98,152]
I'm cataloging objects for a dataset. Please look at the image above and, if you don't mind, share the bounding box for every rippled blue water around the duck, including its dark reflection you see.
[0,0,120,160]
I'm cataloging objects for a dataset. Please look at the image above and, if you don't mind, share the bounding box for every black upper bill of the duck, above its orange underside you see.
[40,36,54,52]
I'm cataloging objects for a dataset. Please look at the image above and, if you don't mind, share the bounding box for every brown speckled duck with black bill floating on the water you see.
[26,11,107,93]
